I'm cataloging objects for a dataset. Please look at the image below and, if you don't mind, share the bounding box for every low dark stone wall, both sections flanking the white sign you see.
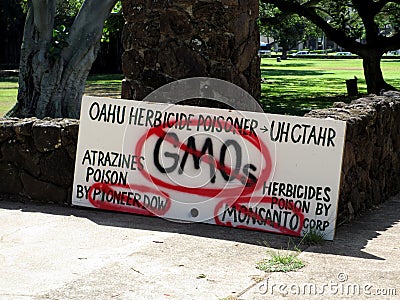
[0,92,400,223]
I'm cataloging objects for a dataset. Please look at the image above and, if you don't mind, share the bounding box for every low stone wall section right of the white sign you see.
[307,92,400,223]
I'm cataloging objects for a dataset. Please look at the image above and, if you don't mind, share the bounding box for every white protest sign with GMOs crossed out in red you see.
[72,97,345,240]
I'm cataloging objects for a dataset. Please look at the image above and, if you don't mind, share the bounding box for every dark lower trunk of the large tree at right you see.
[362,51,396,95]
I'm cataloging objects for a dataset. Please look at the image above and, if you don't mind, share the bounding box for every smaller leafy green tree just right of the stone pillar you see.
[260,3,319,59]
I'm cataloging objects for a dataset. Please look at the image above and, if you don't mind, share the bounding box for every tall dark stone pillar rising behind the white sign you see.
[122,0,261,100]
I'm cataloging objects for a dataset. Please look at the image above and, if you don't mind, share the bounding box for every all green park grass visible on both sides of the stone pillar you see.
[0,58,400,116]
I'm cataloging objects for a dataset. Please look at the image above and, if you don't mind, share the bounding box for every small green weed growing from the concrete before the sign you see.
[256,252,304,273]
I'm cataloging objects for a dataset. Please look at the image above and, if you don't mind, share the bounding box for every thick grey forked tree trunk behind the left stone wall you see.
[8,0,117,118]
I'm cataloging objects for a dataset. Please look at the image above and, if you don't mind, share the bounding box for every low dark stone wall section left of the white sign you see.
[0,118,79,204]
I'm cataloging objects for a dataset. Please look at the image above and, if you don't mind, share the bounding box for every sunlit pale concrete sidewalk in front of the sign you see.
[0,197,400,299]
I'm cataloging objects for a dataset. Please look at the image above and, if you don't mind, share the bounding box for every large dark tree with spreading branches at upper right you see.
[260,0,400,94]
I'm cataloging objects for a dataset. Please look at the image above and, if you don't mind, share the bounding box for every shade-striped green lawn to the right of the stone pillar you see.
[261,58,400,115]
